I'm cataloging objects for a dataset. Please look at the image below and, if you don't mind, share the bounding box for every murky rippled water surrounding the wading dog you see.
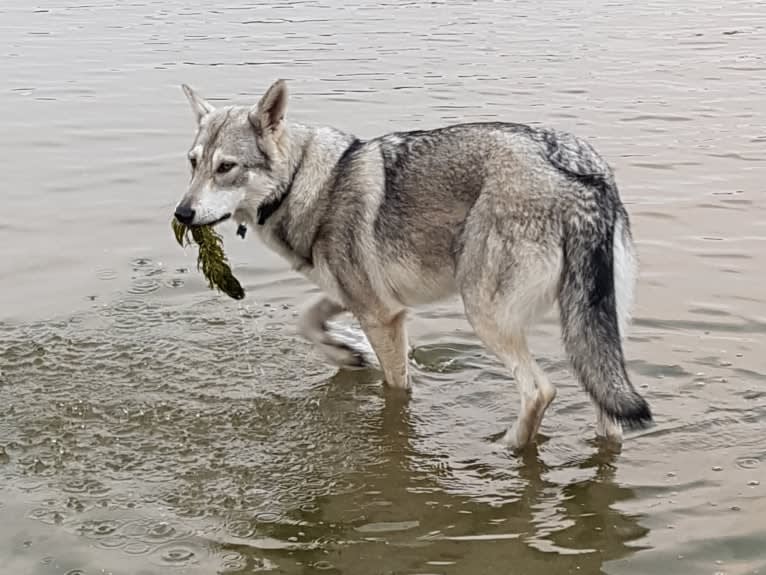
[0,0,766,575]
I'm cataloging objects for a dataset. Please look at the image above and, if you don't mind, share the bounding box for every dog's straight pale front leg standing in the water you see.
[360,311,410,389]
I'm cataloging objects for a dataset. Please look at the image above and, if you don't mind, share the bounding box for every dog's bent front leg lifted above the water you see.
[298,296,370,369]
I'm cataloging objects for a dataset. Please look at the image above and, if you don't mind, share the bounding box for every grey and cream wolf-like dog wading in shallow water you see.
[175,80,652,449]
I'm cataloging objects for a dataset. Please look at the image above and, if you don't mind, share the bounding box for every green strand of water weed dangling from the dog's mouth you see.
[171,218,245,299]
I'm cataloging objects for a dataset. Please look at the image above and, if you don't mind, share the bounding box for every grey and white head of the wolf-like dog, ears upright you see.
[175,80,288,226]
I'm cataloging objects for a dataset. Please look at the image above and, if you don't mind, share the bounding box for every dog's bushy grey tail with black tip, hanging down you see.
[558,179,652,428]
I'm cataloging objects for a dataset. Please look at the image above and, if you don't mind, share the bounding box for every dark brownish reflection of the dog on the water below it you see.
[280,372,648,574]
